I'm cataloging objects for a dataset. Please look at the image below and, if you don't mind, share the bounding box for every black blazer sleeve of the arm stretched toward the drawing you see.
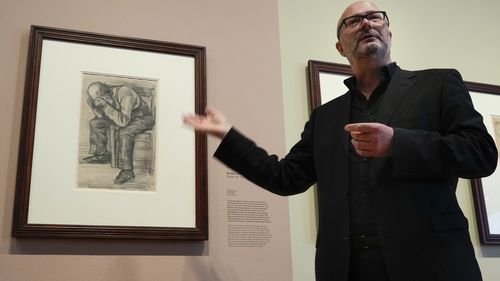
[214,122,316,195]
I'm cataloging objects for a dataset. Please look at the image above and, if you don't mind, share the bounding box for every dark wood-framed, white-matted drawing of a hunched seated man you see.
[12,26,208,240]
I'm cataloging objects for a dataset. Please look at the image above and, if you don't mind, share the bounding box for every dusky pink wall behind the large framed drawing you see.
[0,0,291,281]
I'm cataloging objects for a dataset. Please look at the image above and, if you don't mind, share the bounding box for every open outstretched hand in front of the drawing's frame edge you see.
[182,107,232,139]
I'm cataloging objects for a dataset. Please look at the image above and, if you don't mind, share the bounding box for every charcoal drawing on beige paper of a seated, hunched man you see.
[78,72,158,191]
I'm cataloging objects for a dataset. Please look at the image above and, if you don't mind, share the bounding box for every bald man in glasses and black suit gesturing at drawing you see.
[184,2,497,281]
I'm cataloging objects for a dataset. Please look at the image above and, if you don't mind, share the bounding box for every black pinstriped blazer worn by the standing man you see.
[215,69,497,281]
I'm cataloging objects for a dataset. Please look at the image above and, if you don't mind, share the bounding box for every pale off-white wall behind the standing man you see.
[279,0,500,281]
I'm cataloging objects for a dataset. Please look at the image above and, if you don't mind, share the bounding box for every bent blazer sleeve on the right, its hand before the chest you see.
[393,70,498,178]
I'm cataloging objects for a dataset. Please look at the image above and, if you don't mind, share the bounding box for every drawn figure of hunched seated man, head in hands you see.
[84,82,155,184]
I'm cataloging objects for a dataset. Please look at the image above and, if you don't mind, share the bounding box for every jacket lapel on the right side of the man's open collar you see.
[376,69,415,124]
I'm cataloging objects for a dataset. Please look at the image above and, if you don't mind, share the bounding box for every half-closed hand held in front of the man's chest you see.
[344,123,394,157]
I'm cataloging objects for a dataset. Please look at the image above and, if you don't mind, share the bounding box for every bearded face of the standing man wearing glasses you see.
[336,2,392,61]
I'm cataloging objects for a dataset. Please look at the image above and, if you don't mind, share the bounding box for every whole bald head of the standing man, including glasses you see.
[336,1,392,64]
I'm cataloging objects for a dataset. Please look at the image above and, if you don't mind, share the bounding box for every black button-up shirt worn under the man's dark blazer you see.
[344,63,398,236]
